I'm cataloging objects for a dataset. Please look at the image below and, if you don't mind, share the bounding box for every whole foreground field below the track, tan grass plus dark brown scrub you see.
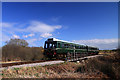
[1,50,120,80]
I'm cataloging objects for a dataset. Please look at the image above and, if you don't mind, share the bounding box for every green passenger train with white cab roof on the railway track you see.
[44,38,99,60]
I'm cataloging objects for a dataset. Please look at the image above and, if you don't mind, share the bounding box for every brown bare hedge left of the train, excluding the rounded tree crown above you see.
[2,45,44,61]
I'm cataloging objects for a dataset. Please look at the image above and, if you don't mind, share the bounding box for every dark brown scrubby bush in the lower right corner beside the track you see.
[77,53,120,80]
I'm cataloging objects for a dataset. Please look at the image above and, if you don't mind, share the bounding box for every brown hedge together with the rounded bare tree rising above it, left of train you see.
[2,39,44,61]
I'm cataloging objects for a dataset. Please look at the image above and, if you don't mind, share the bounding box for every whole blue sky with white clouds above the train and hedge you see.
[0,2,118,49]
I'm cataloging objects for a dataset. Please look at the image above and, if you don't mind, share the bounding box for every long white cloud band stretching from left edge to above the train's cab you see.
[2,21,62,33]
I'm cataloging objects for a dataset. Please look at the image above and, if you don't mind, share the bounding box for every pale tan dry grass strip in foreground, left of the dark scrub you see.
[2,62,107,78]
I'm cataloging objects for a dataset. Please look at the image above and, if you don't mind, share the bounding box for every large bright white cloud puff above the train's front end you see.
[23,21,62,33]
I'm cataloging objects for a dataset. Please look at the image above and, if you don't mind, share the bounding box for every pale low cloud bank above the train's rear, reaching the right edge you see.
[73,39,118,49]
